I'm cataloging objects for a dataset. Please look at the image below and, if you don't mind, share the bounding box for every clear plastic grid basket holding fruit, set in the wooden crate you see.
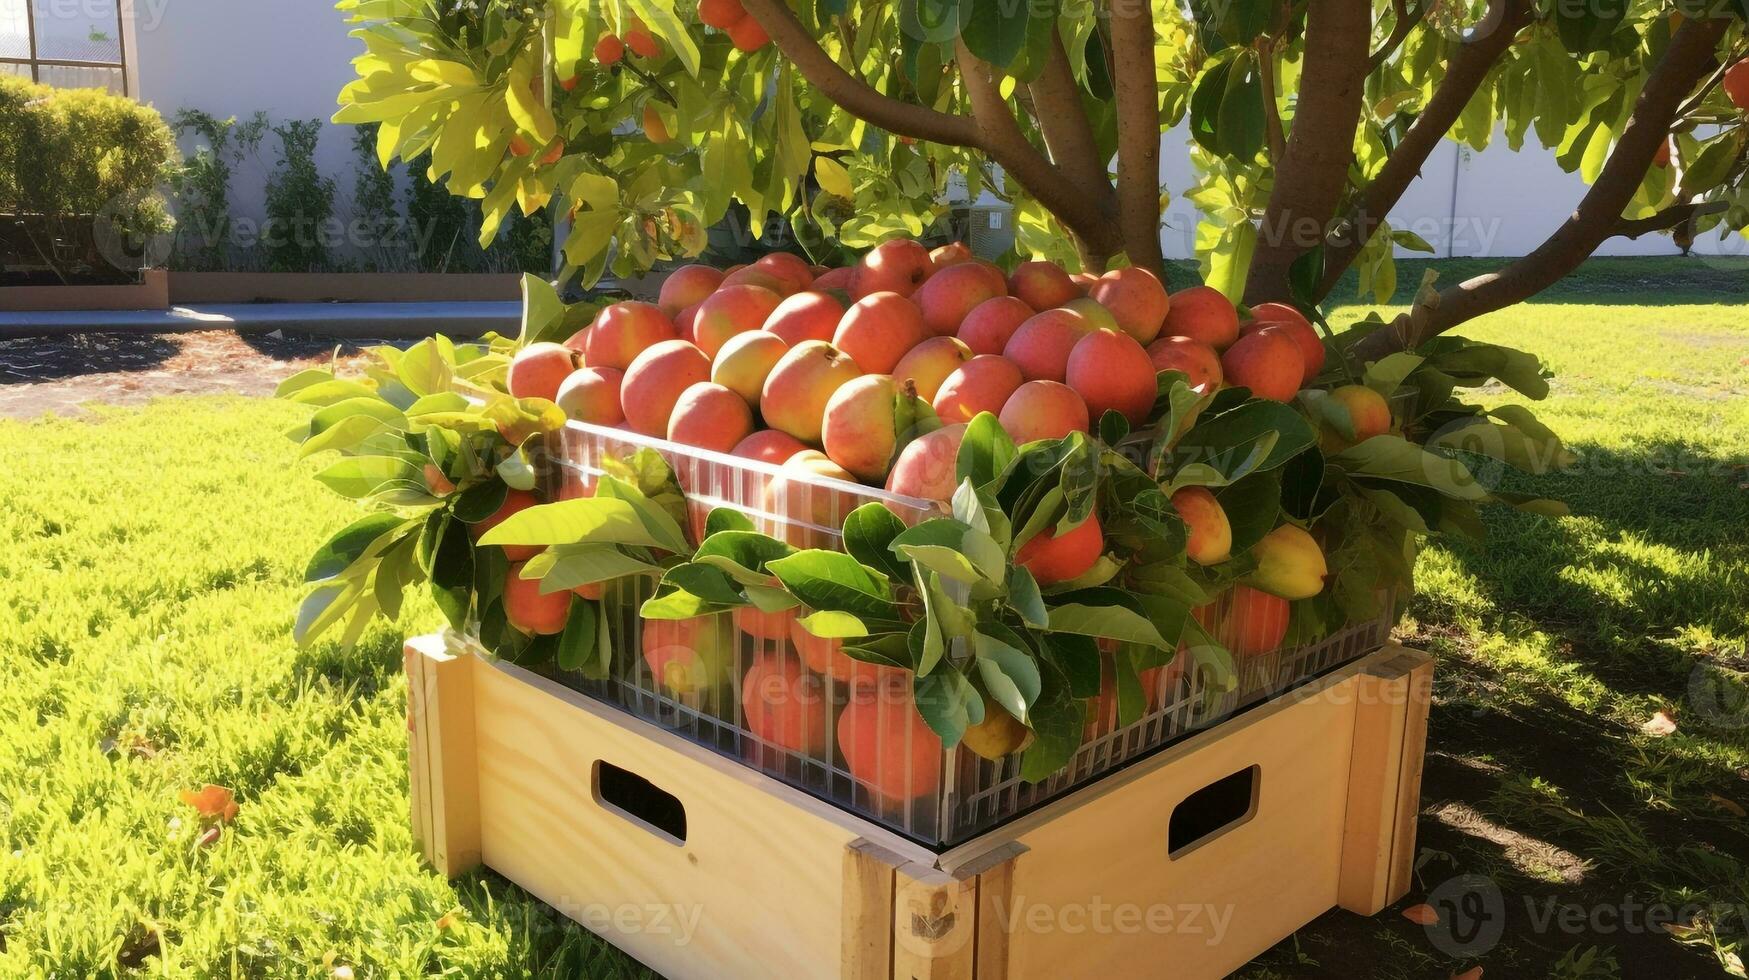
[510,422,1390,849]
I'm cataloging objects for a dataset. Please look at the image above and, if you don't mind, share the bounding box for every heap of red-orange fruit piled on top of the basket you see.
[509,240,1324,501]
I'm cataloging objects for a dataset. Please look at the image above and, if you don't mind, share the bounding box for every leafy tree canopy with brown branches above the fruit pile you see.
[336,0,1749,352]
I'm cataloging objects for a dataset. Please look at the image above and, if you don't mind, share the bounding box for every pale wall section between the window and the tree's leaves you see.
[133,0,362,219]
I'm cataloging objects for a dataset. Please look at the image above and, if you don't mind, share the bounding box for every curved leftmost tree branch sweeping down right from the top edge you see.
[742,0,978,147]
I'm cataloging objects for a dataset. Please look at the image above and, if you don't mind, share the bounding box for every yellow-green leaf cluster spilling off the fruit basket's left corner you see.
[276,277,593,649]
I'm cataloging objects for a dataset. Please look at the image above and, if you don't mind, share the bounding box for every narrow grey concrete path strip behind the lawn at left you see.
[0,303,521,338]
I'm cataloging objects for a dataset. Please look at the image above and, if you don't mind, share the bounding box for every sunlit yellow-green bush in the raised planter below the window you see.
[0,75,177,282]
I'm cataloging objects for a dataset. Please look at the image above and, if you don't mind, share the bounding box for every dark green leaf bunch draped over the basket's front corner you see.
[608,413,1231,779]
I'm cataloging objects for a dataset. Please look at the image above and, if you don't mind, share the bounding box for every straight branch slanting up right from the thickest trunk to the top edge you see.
[1317,0,1530,299]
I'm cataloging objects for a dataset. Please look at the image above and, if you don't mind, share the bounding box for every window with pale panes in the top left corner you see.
[0,0,128,95]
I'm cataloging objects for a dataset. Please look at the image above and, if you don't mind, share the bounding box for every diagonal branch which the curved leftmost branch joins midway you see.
[955,40,1119,256]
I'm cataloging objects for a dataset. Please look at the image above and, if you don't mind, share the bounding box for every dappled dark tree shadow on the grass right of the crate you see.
[1252,441,1749,978]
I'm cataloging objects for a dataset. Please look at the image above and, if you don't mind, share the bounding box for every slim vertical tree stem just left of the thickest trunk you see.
[1105,0,1161,278]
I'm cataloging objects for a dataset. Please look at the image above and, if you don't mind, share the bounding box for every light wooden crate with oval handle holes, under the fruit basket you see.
[406,637,1432,980]
